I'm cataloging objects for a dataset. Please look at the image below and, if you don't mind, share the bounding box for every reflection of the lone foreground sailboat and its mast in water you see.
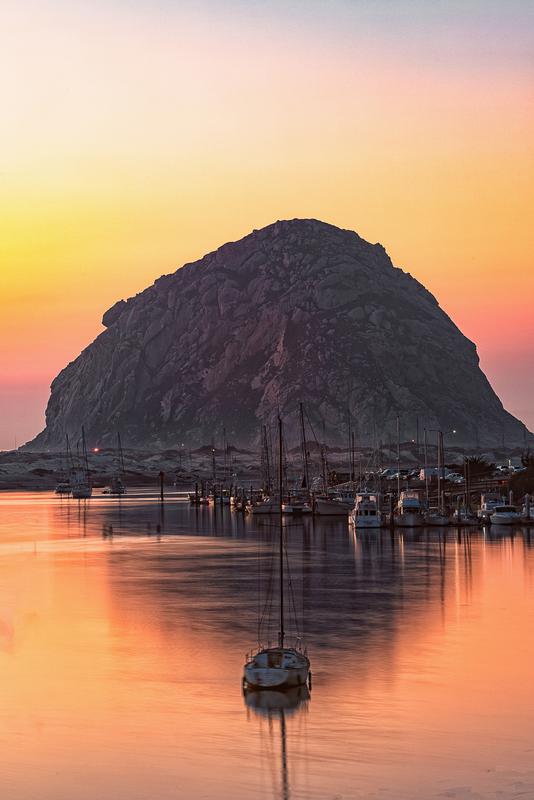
[243,686,311,800]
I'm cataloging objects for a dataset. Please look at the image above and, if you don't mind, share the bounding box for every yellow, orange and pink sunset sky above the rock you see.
[0,0,534,448]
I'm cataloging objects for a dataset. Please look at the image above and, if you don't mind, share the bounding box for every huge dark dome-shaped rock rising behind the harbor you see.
[27,220,525,449]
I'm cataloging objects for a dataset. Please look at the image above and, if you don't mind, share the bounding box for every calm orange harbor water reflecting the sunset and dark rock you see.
[0,493,534,800]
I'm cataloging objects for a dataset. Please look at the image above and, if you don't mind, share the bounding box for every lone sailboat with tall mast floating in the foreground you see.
[243,417,311,689]
